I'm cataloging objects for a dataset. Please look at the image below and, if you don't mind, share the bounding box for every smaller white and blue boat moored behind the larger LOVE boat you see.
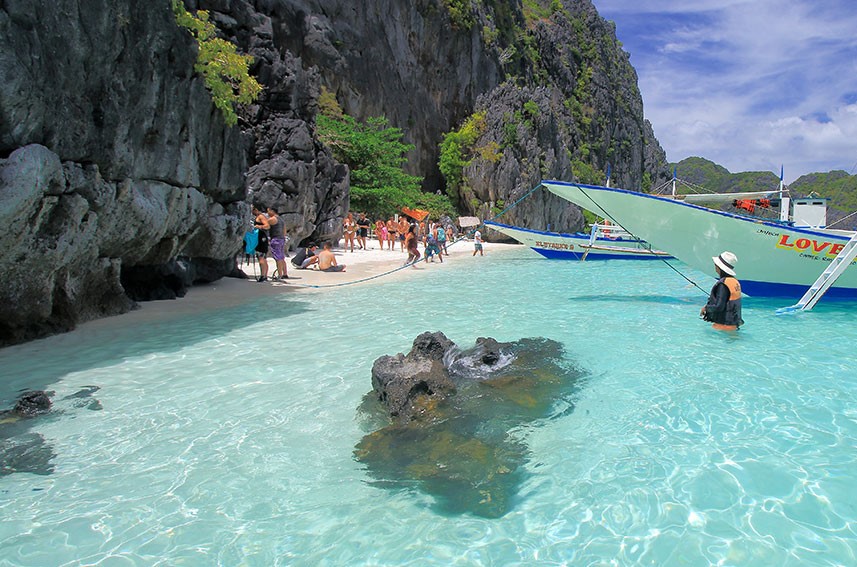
[485,221,670,260]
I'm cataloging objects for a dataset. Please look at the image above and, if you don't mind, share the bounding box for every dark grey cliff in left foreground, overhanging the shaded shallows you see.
[0,0,249,344]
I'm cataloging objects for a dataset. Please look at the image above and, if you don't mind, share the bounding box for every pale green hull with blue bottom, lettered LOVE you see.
[542,181,857,299]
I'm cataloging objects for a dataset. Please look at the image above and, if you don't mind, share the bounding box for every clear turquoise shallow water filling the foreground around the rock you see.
[0,248,857,566]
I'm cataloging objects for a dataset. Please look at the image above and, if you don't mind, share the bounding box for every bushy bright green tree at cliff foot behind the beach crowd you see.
[316,89,454,218]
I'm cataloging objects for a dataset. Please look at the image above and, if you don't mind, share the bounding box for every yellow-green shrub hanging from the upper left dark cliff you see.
[173,0,262,126]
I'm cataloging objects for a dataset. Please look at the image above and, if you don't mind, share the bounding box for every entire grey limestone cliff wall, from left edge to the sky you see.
[0,0,665,345]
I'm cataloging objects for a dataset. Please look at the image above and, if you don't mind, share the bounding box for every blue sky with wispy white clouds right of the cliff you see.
[592,0,857,183]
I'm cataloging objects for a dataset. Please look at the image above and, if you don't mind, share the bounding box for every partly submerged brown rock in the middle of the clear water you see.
[355,333,581,518]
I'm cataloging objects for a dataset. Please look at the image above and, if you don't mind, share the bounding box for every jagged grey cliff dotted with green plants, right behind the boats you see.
[456,1,668,233]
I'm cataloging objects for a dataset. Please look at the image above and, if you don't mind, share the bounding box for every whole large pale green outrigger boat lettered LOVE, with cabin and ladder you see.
[542,181,857,302]
